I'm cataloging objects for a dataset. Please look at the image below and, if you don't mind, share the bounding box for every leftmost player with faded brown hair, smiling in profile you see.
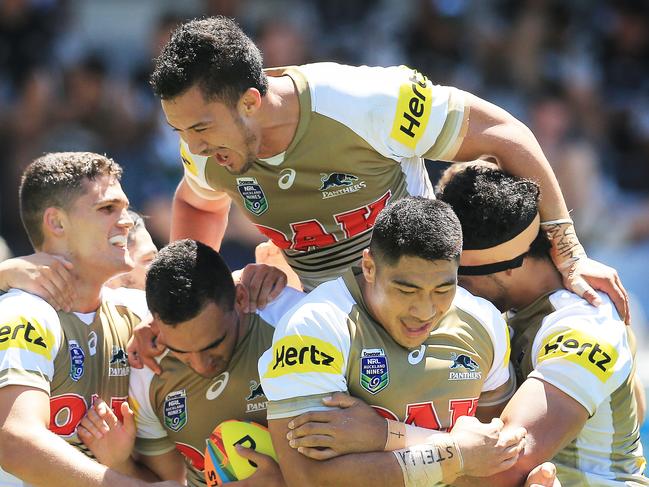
[0,152,178,486]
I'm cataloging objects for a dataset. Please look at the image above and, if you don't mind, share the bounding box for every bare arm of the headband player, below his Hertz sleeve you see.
[454,378,588,487]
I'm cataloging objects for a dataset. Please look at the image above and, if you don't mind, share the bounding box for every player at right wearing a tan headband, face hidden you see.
[440,166,649,487]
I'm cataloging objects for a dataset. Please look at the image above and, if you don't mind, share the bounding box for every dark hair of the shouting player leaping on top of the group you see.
[150,15,268,106]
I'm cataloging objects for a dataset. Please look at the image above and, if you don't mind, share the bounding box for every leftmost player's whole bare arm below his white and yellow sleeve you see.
[0,385,151,487]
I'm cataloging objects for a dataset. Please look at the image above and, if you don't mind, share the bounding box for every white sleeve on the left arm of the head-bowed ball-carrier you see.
[129,367,174,455]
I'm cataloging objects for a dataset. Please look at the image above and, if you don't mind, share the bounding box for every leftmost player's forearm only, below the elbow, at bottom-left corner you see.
[0,427,143,487]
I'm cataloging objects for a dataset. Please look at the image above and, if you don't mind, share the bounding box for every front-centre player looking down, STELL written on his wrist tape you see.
[259,197,548,486]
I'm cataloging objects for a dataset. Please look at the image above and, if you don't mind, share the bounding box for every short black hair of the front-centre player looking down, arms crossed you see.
[370,197,462,265]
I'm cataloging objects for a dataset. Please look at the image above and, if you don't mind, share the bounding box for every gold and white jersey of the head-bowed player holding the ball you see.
[130,288,303,486]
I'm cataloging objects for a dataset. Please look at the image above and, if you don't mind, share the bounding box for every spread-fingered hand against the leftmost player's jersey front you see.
[77,399,136,470]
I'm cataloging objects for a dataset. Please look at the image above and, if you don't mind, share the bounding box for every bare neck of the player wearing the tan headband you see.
[510,257,563,310]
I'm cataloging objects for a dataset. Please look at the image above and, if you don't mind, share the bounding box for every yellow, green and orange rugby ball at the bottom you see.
[205,420,277,486]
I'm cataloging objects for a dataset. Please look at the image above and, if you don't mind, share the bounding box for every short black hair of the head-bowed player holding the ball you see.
[145,239,235,326]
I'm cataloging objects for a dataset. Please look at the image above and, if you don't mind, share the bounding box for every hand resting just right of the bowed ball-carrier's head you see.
[233,264,286,313]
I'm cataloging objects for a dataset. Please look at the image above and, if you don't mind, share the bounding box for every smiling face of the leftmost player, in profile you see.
[60,175,133,282]
